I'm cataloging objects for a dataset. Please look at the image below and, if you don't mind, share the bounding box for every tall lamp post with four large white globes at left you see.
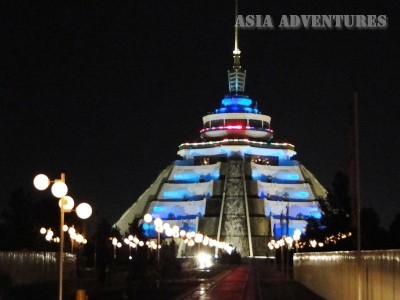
[33,173,92,300]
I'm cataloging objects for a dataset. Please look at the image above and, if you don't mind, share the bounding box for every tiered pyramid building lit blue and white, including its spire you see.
[115,12,326,256]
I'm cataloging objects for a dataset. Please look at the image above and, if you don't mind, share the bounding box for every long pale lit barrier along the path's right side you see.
[293,250,400,300]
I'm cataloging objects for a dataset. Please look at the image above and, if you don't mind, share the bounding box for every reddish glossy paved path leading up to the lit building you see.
[177,259,322,300]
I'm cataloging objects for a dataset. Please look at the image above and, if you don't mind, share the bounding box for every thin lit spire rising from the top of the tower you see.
[228,0,246,95]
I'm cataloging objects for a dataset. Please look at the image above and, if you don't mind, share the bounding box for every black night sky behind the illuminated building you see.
[0,0,400,226]
